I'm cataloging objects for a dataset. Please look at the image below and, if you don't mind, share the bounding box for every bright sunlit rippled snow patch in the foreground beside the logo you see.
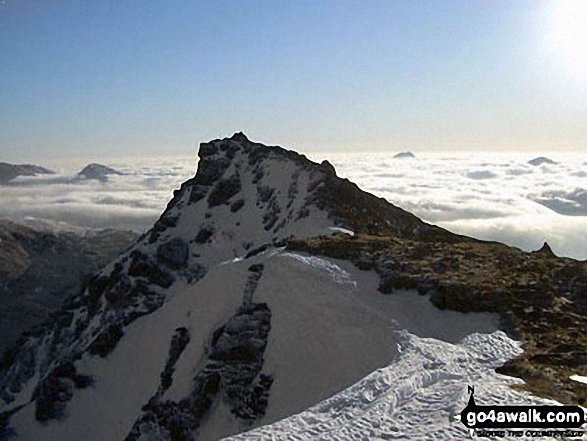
[228,331,555,441]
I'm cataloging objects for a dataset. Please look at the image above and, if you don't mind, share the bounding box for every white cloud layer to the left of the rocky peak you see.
[0,155,197,231]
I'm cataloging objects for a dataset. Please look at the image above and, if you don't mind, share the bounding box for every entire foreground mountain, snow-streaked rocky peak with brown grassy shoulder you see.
[0,133,587,440]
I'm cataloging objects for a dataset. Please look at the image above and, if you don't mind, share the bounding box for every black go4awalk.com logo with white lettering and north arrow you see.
[460,386,585,438]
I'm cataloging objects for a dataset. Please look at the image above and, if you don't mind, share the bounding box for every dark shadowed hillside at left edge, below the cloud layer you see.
[0,220,138,352]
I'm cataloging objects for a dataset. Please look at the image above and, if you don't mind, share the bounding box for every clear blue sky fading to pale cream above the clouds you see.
[0,0,587,161]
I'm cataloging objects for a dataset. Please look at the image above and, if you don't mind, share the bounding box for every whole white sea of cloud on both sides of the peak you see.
[0,152,587,259]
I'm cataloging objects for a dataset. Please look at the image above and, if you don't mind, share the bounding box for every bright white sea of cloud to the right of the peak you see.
[316,153,587,260]
